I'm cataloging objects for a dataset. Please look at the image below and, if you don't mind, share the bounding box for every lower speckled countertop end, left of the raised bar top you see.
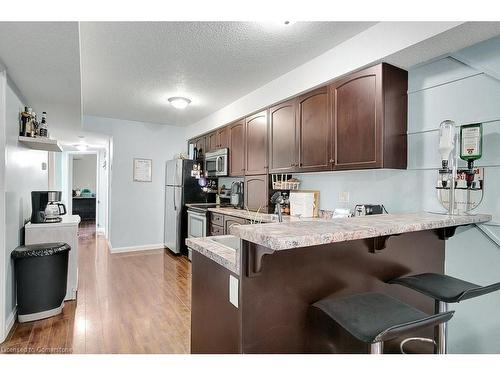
[186,235,240,275]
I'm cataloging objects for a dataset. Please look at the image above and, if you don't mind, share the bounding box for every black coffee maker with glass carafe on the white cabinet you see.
[31,191,66,224]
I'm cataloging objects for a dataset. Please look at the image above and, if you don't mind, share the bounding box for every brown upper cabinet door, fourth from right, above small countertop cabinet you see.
[245,111,268,175]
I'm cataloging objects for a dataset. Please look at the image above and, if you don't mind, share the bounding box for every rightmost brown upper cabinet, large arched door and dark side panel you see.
[330,64,408,170]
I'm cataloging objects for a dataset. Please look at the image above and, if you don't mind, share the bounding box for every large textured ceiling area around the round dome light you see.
[81,22,374,125]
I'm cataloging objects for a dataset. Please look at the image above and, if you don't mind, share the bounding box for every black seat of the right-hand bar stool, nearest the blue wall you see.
[389,273,500,303]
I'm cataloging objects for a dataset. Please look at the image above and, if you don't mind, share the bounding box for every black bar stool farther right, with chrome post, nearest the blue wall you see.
[388,273,500,354]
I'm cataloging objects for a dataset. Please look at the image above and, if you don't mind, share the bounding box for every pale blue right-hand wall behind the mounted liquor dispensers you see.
[409,38,500,353]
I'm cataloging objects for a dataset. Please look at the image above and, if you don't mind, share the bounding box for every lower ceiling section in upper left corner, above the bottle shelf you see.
[0,22,81,137]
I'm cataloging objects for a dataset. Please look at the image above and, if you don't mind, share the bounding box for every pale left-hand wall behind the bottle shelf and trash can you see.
[2,74,48,338]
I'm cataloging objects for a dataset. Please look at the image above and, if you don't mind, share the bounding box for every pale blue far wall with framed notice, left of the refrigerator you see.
[84,116,186,251]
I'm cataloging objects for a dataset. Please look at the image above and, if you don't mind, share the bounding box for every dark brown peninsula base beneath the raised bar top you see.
[191,230,444,354]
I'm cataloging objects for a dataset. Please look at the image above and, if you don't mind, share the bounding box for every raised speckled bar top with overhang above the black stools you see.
[231,212,491,251]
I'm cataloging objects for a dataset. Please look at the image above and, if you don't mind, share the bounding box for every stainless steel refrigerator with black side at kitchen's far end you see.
[164,159,215,255]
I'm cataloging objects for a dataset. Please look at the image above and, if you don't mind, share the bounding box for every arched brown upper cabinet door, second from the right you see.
[297,87,332,172]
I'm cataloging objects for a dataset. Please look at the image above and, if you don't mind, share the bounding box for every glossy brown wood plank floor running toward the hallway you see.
[0,223,191,354]
